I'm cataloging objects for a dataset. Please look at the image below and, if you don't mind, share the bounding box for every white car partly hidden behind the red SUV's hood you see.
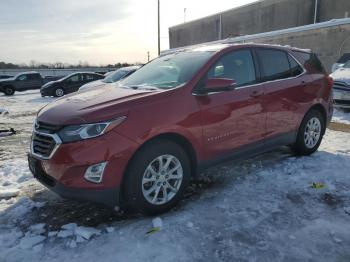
[79,66,140,91]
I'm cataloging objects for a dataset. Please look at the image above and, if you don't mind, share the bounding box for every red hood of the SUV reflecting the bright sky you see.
[38,85,162,125]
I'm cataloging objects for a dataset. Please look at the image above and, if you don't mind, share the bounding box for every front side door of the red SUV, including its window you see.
[197,49,266,158]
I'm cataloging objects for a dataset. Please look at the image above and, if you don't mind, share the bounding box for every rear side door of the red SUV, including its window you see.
[255,48,311,140]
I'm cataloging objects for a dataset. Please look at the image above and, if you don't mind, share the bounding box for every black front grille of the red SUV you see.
[32,132,56,158]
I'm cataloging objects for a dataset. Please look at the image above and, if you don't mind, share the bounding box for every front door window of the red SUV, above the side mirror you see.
[207,50,256,86]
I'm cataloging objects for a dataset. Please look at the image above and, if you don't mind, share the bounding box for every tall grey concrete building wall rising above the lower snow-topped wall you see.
[169,0,350,48]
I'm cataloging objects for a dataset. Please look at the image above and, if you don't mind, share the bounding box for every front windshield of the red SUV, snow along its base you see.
[120,51,213,89]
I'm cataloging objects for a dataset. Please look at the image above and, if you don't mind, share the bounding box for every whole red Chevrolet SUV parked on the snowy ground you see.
[29,44,333,214]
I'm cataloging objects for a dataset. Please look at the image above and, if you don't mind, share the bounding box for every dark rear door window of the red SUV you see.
[257,49,291,81]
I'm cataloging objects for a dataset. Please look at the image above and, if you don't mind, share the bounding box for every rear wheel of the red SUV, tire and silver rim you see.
[292,109,326,156]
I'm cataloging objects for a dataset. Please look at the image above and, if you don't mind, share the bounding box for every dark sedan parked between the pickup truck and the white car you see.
[40,72,104,97]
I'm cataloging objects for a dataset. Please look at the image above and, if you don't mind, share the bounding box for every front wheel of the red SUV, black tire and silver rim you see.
[123,139,191,215]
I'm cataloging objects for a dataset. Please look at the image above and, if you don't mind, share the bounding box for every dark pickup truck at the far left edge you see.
[0,72,47,95]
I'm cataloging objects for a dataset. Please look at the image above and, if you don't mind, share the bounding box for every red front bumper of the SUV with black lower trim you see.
[28,130,138,207]
